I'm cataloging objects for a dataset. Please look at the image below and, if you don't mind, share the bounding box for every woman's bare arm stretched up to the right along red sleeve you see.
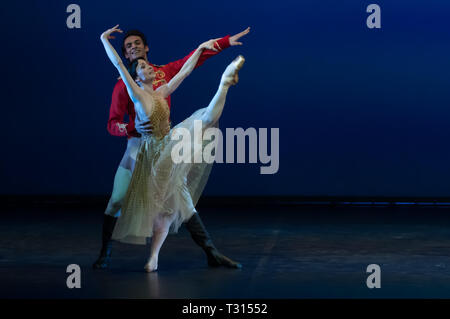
[157,39,218,97]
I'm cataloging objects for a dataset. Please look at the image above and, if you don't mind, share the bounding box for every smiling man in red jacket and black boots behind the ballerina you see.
[93,28,250,269]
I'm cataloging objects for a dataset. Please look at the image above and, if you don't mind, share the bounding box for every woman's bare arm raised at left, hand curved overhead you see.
[100,25,142,103]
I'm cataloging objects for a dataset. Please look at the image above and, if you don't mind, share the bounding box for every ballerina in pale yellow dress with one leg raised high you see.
[100,25,245,272]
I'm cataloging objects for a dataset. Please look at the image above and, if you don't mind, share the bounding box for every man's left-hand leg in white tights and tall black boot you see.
[92,138,139,269]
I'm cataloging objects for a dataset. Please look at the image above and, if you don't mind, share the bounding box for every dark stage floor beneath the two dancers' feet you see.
[0,206,450,299]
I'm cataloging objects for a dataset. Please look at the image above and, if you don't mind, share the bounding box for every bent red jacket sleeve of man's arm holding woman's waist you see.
[107,80,134,136]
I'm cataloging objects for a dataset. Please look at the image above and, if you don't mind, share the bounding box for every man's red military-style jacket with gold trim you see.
[107,35,230,137]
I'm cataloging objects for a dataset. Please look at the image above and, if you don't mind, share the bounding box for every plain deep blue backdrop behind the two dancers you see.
[0,0,450,197]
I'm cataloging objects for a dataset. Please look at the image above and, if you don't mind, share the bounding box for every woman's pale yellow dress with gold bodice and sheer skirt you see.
[112,95,218,244]
